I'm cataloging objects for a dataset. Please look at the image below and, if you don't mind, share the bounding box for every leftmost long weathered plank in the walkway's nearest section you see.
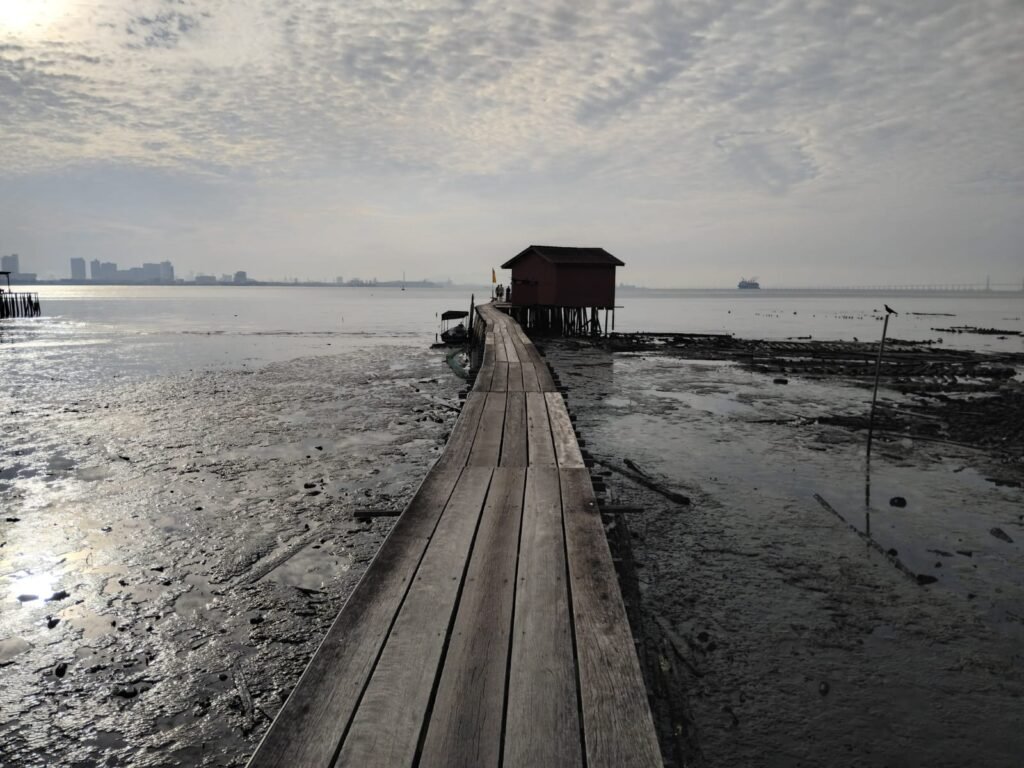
[249,465,462,768]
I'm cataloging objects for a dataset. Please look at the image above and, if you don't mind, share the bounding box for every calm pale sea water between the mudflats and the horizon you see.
[0,286,1024,394]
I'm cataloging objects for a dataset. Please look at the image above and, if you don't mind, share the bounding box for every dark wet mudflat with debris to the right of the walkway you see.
[545,336,1024,768]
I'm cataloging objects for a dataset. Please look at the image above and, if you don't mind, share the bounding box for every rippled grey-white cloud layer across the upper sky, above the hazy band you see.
[0,0,1024,282]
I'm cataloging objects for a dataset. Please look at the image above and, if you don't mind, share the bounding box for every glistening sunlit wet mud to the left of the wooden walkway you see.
[0,346,459,766]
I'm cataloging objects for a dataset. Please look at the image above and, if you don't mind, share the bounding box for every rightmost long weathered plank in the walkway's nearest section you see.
[559,469,662,768]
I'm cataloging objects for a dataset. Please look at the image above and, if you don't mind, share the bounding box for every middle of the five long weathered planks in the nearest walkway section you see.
[420,468,526,768]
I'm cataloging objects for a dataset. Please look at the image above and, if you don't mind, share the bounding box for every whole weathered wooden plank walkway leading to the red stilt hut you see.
[249,305,662,768]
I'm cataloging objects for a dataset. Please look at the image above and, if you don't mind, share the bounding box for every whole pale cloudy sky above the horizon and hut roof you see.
[0,0,1024,287]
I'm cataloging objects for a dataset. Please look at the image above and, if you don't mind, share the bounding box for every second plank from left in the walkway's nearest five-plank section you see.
[337,467,492,768]
